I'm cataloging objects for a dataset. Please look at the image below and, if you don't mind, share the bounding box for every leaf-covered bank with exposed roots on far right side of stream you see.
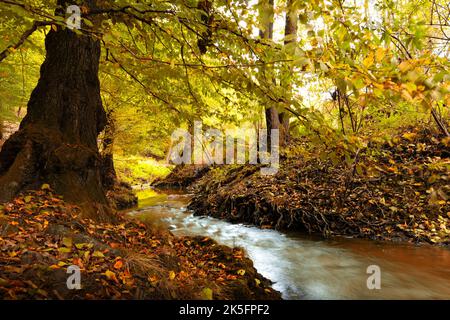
[163,128,450,245]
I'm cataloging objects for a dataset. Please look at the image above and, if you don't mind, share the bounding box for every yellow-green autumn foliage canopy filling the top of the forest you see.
[0,0,449,155]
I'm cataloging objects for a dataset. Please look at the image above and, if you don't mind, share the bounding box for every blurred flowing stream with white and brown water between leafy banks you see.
[130,192,450,299]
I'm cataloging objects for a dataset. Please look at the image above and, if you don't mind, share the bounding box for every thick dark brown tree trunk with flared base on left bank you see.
[0,0,111,220]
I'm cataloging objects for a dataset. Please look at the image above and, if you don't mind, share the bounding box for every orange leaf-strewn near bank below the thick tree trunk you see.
[0,185,281,299]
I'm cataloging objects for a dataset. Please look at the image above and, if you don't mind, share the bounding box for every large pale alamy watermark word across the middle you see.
[168,121,280,175]
